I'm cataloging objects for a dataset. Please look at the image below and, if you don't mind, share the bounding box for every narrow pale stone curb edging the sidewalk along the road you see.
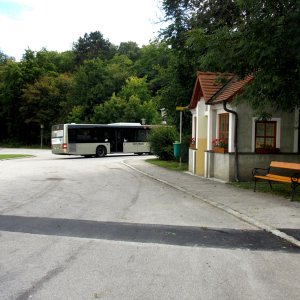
[122,162,300,248]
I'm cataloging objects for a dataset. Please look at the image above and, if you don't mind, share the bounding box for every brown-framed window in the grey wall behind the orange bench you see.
[255,121,277,151]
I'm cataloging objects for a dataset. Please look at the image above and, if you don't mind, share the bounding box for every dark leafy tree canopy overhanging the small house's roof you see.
[163,0,300,112]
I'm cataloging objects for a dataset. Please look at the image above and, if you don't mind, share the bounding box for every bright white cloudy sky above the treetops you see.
[0,0,163,61]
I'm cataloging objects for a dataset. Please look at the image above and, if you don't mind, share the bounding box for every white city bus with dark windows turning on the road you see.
[51,123,150,157]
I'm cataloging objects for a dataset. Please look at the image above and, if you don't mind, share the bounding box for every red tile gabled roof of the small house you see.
[189,72,253,109]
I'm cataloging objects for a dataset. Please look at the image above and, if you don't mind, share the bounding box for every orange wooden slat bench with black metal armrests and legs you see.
[252,161,300,201]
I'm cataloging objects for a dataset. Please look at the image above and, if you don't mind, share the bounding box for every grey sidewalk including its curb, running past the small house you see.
[124,160,300,248]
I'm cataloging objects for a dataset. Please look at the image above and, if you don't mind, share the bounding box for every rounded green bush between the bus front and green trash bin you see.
[149,126,178,160]
